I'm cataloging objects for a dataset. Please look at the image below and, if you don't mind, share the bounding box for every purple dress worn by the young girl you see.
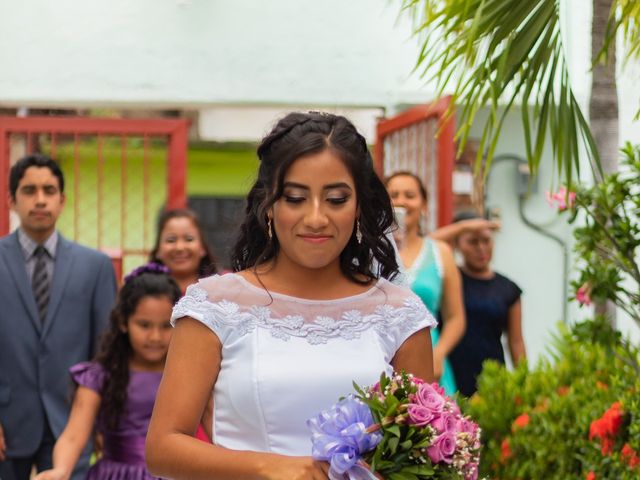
[69,362,162,480]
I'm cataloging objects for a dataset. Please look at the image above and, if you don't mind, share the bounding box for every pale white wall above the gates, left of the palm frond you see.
[0,0,433,107]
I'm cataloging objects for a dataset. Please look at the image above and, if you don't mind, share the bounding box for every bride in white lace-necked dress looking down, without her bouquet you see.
[146,112,435,480]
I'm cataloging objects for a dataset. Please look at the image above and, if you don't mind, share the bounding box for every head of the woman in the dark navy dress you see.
[454,211,493,276]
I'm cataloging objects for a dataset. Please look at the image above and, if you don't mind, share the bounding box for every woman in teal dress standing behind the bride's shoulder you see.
[387,172,465,395]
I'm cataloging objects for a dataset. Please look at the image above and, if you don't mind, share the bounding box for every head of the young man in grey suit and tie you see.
[9,153,65,243]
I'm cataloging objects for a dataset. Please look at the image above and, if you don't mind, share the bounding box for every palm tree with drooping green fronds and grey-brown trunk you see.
[403,0,640,183]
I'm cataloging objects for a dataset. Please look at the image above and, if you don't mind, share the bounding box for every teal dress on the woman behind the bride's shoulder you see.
[406,237,457,395]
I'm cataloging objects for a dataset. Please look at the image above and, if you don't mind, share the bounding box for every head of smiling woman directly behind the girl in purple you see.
[149,208,217,291]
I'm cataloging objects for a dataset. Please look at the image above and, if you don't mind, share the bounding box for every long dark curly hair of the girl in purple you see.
[95,267,181,428]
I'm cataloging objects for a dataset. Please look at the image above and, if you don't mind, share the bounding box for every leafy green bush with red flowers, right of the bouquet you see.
[463,317,640,480]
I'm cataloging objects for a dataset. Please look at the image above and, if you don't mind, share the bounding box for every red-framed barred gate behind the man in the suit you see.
[0,117,188,278]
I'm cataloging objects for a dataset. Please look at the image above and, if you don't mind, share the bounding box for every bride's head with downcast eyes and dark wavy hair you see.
[233,112,398,283]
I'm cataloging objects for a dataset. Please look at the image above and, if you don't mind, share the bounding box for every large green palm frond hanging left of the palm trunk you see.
[403,0,604,181]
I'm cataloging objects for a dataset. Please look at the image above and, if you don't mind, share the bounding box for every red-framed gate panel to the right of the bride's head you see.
[375,97,455,230]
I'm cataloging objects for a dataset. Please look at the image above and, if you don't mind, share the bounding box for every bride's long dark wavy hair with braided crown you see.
[232,112,398,284]
